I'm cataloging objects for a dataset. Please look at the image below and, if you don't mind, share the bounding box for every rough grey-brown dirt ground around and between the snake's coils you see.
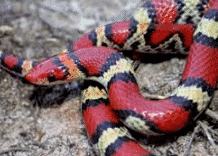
[0,0,218,156]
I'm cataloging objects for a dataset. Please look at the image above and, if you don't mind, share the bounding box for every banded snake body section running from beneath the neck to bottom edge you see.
[82,81,153,156]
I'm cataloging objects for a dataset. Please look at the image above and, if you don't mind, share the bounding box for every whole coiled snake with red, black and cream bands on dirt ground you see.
[0,0,218,156]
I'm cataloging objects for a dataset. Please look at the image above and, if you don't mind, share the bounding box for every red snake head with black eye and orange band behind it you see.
[25,52,84,85]
